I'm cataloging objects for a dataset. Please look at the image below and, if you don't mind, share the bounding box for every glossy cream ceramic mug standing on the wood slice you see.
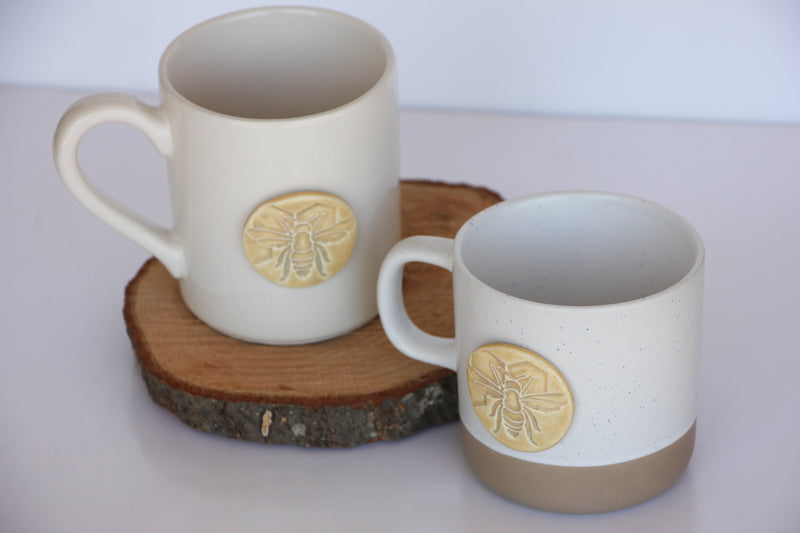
[54,7,400,344]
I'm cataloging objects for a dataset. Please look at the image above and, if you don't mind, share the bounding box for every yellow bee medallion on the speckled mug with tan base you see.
[467,343,575,452]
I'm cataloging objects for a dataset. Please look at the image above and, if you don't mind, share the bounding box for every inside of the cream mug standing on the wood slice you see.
[161,7,391,119]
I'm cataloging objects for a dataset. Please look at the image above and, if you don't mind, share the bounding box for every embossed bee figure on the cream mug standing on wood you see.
[247,202,353,281]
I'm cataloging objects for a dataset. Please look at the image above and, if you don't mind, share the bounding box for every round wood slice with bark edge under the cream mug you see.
[124,181,501,447]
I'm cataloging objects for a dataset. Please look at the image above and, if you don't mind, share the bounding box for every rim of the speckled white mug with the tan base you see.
[453,190,705,312]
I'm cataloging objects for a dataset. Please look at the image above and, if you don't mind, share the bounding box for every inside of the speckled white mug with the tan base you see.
[457,193,703,306]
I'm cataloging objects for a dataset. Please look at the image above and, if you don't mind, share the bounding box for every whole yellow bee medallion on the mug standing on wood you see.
[243,191,356,288]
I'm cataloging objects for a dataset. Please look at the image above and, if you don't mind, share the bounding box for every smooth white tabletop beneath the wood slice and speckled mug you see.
[0,87,800,533]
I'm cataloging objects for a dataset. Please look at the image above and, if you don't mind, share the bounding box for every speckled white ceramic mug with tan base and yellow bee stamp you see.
[378,192,704,513]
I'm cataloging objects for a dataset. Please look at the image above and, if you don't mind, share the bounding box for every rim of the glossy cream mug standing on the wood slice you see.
[158,5,397,125]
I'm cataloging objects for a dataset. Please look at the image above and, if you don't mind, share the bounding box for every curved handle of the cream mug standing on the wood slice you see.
[53,93,186,278]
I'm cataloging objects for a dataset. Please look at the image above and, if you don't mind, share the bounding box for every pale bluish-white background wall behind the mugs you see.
[0,0,800,122]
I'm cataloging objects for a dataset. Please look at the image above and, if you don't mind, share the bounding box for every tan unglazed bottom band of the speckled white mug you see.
[461,423,696,514]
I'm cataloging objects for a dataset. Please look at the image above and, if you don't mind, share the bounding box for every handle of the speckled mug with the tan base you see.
[378,236,458,370]
